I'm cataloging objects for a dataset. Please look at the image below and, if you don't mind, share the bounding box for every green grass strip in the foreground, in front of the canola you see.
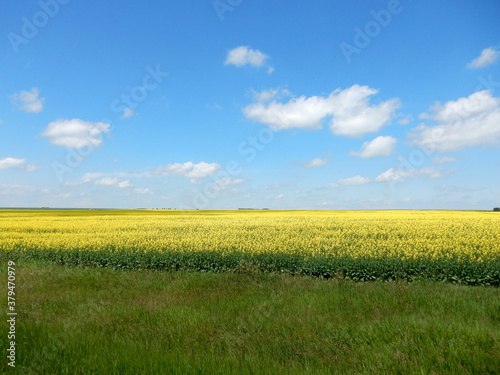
[0,260,500,374]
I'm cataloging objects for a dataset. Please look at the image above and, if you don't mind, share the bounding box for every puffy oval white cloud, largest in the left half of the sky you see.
[41,119,110,149]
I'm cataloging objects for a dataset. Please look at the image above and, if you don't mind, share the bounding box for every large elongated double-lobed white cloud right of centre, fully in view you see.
[243,85,400,137]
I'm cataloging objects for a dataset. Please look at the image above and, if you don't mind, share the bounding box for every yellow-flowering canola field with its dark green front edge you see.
[0,210,500,287]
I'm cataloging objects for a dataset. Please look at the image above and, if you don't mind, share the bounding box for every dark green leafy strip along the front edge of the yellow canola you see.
[3,248,500,287]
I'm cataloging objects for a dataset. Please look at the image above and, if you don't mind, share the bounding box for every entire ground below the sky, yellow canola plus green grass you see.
[0,210,500,374]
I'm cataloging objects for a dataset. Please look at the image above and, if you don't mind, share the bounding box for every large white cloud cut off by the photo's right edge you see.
[410,90,500,151]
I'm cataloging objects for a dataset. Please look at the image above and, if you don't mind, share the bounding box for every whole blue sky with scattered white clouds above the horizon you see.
[0,0,500,209]
